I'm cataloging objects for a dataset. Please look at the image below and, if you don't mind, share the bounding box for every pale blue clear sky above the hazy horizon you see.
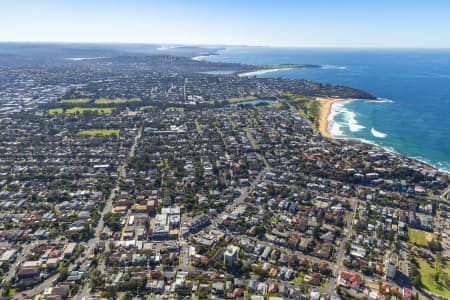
[0,0,450,48]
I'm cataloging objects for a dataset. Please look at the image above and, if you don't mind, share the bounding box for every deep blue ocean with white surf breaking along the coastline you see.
[204,47,450,171]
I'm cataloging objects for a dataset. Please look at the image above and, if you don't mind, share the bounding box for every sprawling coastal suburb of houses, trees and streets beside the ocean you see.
[0,47,450,300]
